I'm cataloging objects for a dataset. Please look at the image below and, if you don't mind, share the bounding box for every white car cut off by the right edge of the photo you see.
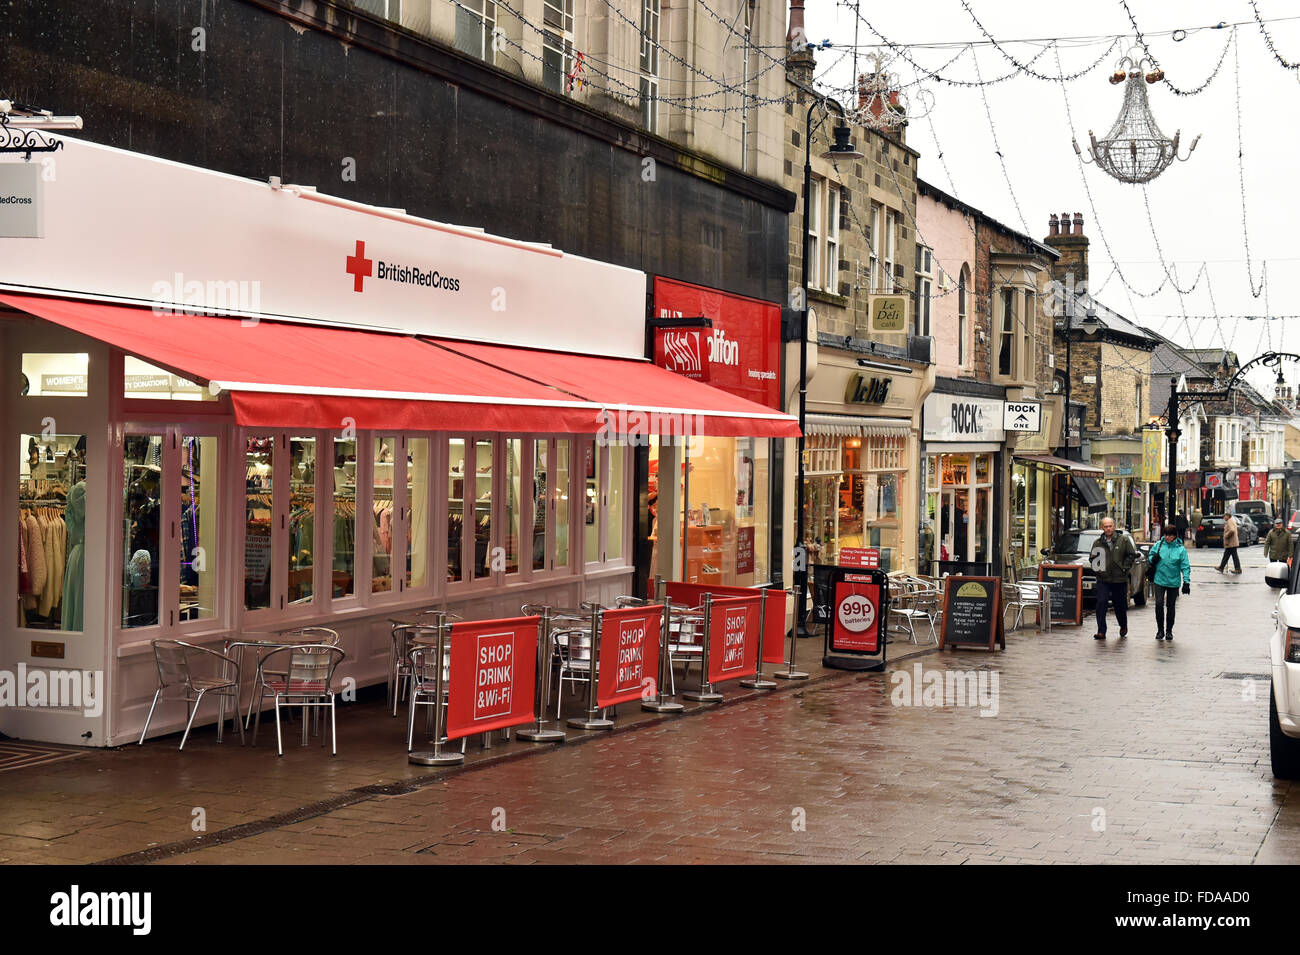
[1264,560,1300,780]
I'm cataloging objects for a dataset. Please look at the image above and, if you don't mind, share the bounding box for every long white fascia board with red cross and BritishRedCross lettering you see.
[0,136,646,357]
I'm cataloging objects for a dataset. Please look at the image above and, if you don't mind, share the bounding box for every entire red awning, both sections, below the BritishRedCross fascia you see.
[0,294,798,437]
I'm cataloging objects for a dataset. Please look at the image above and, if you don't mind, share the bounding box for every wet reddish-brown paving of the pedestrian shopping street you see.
[0,548,1300,864]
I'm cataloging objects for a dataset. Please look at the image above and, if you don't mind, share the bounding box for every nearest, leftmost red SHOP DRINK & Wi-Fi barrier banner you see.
[447,617,540,739]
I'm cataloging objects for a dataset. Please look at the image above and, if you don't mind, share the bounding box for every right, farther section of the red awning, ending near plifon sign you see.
[428,339,800,438]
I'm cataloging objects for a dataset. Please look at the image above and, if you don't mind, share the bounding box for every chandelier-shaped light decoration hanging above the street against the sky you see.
[1071,56,1201,183]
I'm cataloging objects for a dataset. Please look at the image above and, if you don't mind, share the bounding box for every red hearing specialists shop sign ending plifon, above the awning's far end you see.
[654,277,781,409]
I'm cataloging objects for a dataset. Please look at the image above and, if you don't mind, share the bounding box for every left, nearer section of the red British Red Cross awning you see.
[0,295,599,433]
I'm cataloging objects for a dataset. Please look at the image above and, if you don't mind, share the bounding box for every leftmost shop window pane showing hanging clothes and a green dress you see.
[17,434,86,630]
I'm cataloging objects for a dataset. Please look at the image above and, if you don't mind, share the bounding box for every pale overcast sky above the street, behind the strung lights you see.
[806,0,1300,395]
